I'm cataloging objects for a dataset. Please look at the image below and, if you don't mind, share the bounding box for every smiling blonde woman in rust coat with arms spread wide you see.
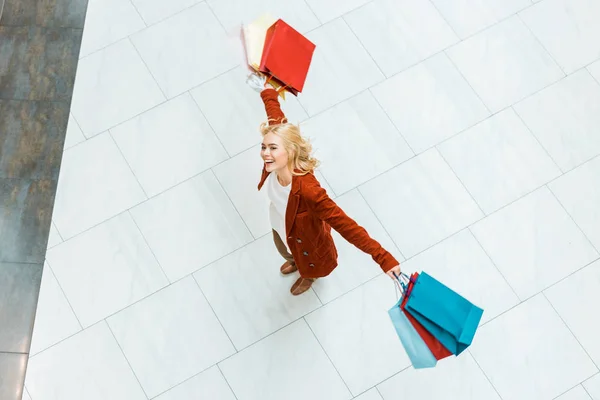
[258,79,400,296]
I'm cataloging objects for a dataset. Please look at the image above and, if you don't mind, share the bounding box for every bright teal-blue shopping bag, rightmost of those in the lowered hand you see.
[405,272,483,355]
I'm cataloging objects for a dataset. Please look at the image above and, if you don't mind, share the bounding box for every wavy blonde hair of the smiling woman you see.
[260,122,320,175]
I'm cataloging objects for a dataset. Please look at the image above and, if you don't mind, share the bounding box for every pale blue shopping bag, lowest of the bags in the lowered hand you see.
[388,278,437,369]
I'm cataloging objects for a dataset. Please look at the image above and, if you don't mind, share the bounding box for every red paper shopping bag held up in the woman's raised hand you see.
[259,19,315,96]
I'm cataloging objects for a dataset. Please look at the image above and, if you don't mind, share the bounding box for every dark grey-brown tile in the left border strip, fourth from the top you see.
[0,178,56,263]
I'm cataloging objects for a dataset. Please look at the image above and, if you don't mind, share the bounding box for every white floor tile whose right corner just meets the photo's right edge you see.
[471,187,598,299]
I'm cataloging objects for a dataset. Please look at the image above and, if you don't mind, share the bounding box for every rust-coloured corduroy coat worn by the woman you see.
[258,89,399,278]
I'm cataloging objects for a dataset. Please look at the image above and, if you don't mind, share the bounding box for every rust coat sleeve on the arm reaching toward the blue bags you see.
[303,174,400,272]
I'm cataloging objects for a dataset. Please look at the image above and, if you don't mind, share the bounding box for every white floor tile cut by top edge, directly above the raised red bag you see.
[207,0,320,33]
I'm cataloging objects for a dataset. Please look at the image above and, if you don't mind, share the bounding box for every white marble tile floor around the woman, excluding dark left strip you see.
[25,0,600,400]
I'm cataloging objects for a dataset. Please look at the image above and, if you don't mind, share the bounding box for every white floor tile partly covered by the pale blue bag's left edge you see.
[306,274,410,396]
